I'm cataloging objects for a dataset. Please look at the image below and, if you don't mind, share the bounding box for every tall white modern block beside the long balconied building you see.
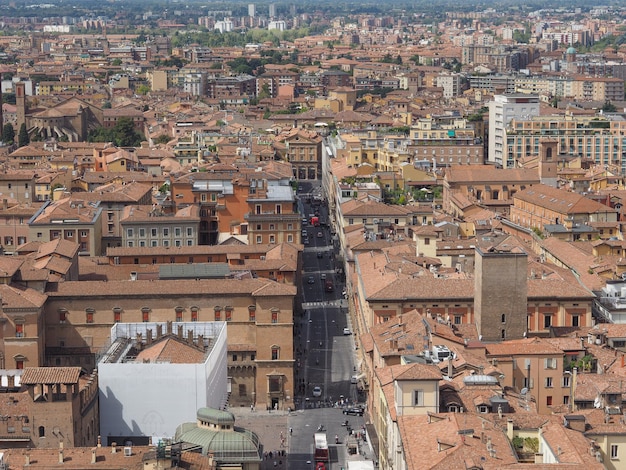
[487,93,539,168]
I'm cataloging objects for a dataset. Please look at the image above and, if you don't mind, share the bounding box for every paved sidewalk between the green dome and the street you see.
[228,407,289,470]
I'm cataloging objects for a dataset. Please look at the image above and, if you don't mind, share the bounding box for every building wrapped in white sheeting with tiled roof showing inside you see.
[98,322,228,446]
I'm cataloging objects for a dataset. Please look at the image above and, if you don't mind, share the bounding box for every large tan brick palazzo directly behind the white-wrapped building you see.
[44,279,297,409]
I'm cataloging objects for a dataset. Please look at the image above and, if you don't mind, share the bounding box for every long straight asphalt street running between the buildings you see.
[288,183,369,470]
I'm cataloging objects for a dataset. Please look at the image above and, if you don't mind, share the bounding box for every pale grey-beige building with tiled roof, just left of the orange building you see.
[120,205,200,248]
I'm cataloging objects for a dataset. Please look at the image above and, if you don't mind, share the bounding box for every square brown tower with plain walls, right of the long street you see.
[474,233,528,341]
